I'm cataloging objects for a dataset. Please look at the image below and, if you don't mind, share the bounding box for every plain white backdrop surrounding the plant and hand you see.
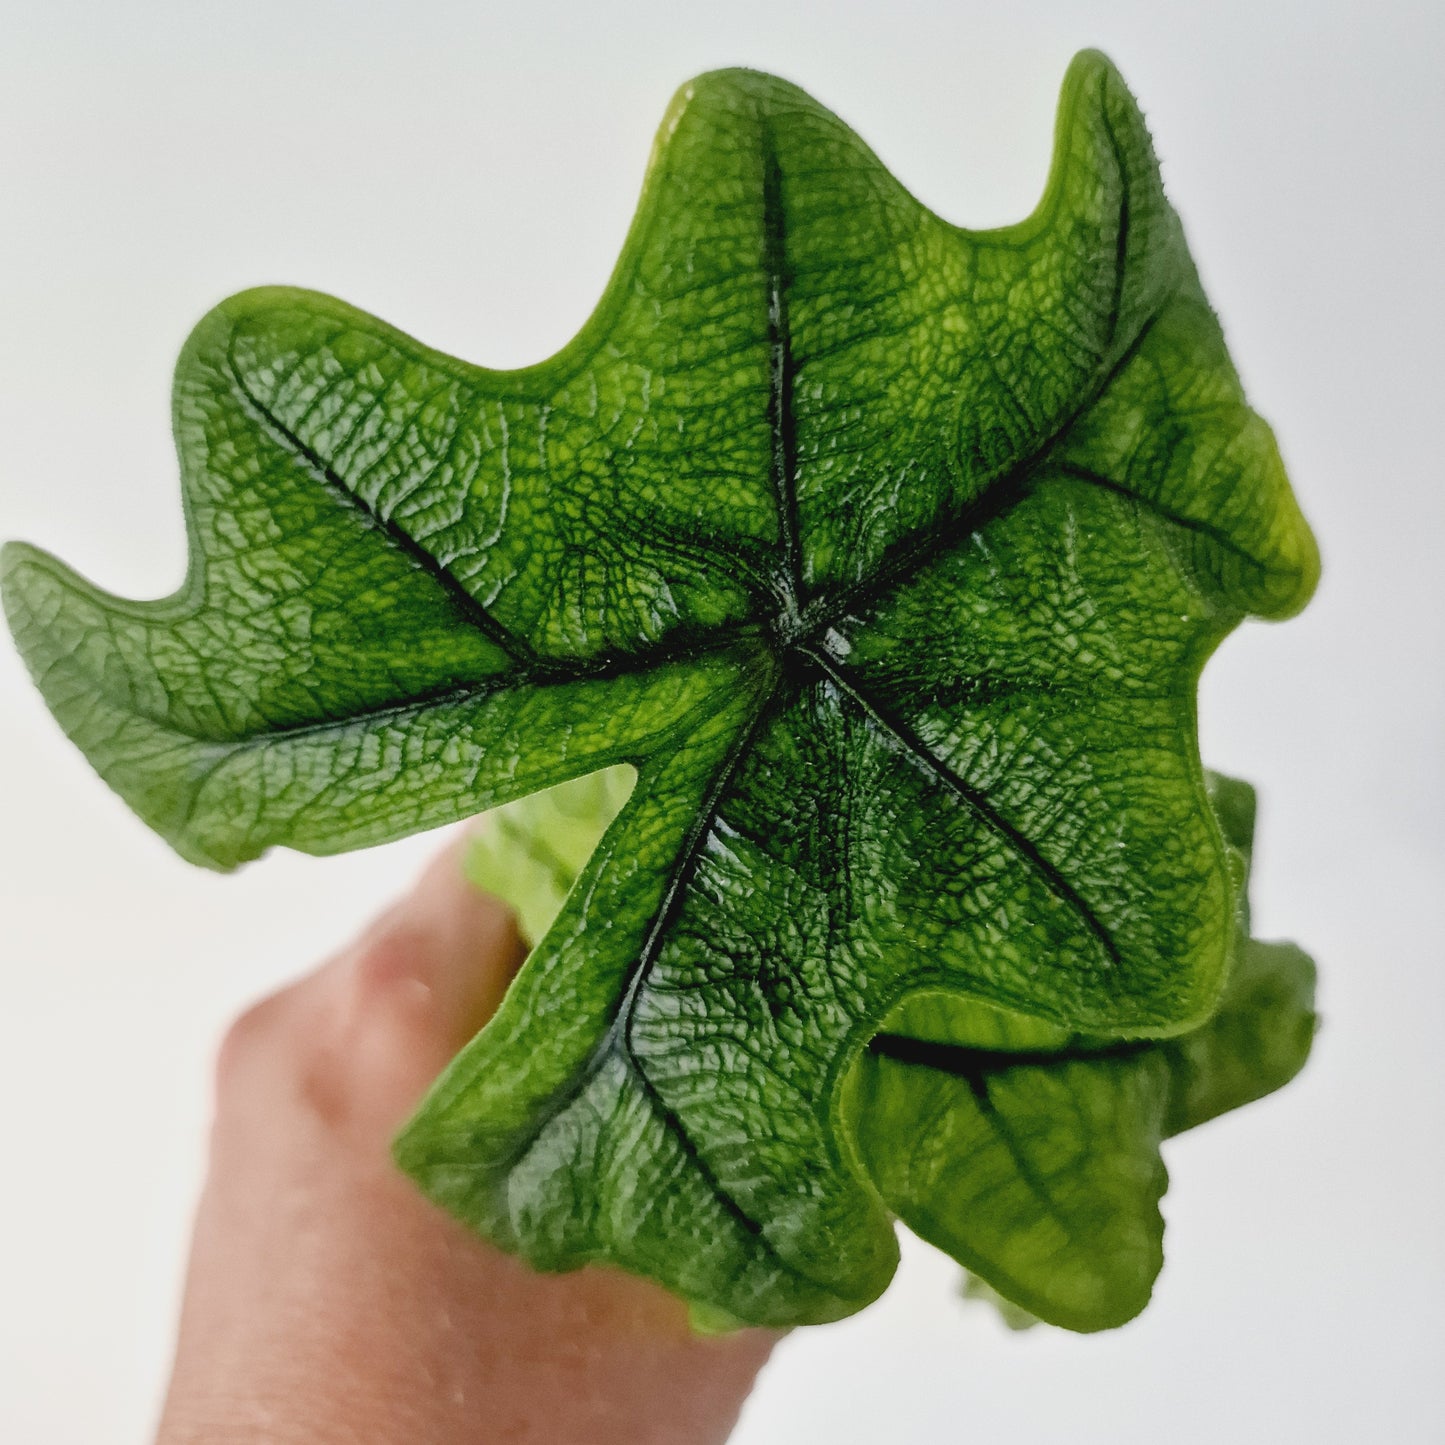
[0,0,1445,1445]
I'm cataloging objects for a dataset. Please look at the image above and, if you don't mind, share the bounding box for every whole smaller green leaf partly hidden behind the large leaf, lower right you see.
[850,776,1315,1329]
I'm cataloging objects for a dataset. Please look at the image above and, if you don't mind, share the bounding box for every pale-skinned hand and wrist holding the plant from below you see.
[156,841,777,1445]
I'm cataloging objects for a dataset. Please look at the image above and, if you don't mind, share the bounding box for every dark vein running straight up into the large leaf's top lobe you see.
[763,121,803,631]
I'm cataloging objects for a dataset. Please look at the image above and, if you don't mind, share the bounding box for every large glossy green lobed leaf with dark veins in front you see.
[3,53,1318,1324]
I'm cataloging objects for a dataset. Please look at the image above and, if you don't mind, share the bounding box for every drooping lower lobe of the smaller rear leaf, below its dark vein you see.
[847,1036,1169,1329]
